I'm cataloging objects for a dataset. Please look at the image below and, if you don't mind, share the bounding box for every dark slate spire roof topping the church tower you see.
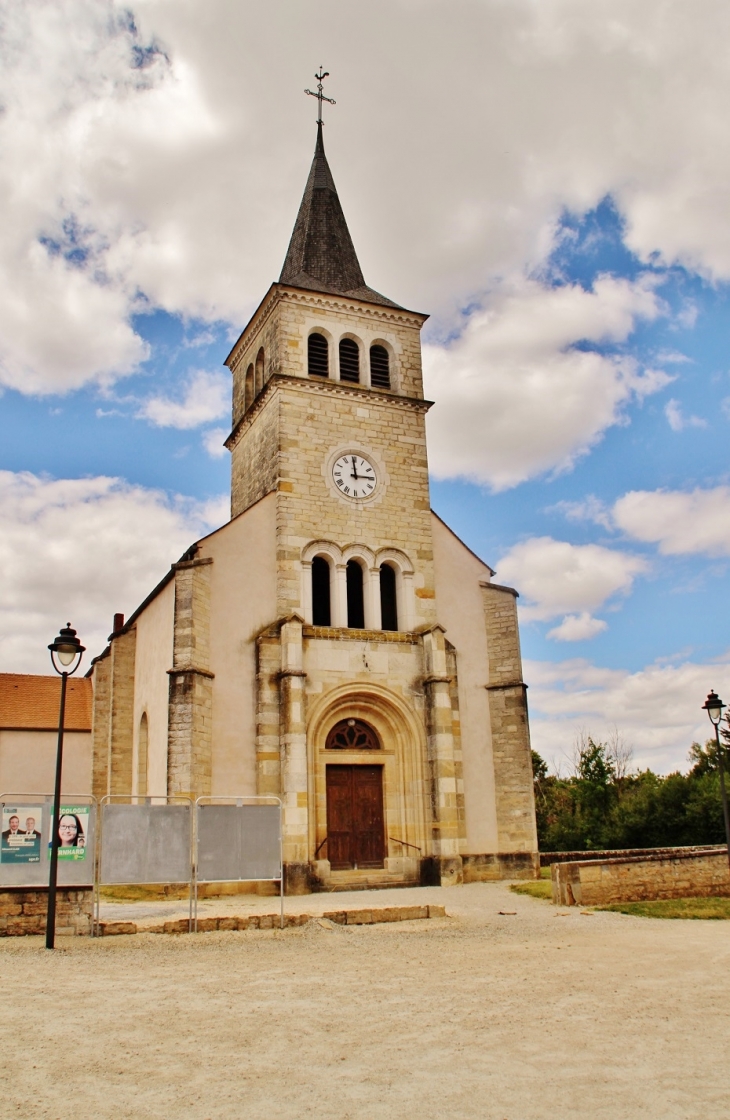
[279,122,399,307]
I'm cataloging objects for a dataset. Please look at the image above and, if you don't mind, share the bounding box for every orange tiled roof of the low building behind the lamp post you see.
[0,673,92,731]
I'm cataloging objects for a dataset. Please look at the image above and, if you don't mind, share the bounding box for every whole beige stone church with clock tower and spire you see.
[93,125,537,893]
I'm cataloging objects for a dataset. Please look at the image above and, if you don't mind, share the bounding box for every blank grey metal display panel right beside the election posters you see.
[99,804,193,884]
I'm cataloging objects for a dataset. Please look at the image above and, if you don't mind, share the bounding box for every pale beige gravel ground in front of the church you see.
[0,884,730,1120]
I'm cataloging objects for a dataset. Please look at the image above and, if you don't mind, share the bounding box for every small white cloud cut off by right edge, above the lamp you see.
[612,486,730,557]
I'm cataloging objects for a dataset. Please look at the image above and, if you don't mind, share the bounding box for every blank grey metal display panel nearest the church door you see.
[197,804,281,883]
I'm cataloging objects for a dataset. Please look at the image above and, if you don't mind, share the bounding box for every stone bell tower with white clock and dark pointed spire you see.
[226,122,434,629]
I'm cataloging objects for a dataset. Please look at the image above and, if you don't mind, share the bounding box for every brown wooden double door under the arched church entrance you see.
[327,765,385,871]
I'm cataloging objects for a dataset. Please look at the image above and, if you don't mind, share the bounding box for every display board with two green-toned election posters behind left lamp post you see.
[0,793,96,888]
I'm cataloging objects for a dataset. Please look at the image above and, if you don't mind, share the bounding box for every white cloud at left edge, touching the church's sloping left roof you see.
[0,470,228,673]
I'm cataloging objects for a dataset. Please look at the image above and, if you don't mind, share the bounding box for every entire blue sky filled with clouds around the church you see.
[0,0,730,771]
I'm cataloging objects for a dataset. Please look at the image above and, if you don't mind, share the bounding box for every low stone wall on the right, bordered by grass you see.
[552,848,730,906]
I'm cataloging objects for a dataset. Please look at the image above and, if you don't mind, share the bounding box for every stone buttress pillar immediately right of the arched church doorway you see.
[423,625,464,885]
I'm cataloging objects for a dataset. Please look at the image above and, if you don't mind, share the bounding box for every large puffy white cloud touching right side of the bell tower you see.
[423,277,670,489]
